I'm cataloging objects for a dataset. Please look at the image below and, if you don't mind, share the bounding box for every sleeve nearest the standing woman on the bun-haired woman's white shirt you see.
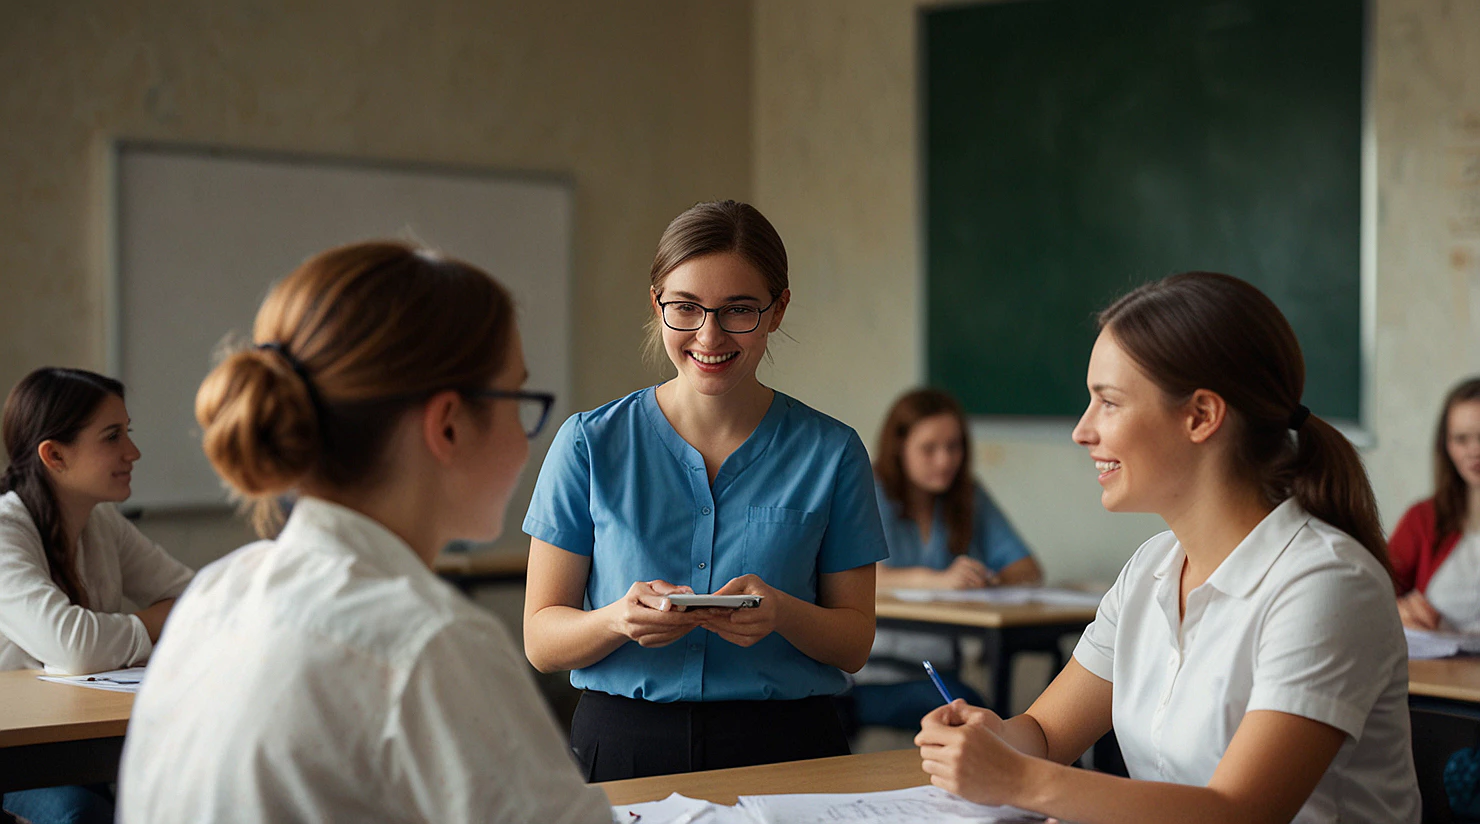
[385,621,611,824]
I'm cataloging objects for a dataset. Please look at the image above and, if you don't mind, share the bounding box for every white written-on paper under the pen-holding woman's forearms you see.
[737,787,1043,824]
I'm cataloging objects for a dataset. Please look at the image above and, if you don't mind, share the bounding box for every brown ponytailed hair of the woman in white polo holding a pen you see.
[1100,272,1393,574]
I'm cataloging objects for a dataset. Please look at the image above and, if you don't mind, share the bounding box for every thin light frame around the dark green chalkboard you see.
[913,0,1378,448]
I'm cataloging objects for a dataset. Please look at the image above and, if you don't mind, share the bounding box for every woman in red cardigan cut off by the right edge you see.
[1388,377,1480,632]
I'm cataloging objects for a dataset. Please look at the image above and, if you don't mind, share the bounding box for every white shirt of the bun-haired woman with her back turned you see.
[118,499,611,824]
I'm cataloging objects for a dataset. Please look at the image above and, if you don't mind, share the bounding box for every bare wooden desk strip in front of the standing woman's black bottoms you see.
[596,750,929,805]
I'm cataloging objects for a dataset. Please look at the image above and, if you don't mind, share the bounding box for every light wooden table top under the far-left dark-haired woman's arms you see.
[0,670,133,747]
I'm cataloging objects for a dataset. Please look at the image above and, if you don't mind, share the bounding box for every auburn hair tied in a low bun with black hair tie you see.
[195,241,514,533]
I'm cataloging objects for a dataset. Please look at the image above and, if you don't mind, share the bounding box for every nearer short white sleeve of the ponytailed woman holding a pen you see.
[1248,567,1407,738]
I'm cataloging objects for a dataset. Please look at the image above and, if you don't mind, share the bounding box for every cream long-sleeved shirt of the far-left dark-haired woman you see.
[0,493,194,673]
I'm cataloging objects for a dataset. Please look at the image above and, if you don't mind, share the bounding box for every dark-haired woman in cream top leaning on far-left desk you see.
[0,367,191,824]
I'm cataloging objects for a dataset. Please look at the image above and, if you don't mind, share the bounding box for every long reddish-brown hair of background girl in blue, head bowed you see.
[873,389,975,555]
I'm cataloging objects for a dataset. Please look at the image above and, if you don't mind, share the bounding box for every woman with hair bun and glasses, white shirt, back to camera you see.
[118,243,611,824]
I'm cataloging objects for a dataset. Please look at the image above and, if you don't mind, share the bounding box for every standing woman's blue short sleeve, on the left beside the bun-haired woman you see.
[524,414,596,555]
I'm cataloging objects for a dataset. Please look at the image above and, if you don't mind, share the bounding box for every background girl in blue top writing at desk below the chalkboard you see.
[852,389,1043,729]
